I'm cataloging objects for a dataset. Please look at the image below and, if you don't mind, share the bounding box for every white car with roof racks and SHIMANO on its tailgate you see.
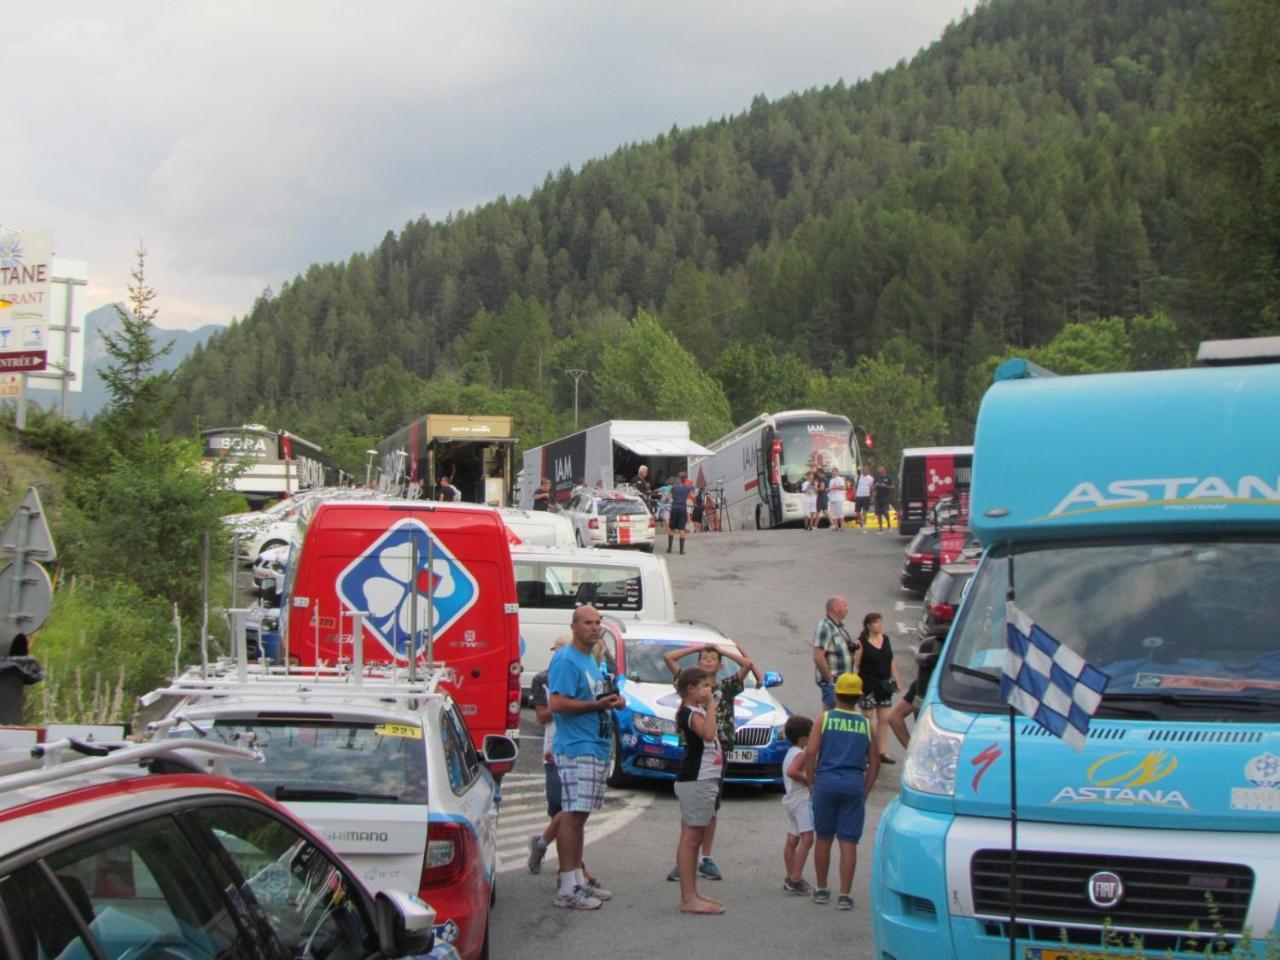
[152,666,516,960]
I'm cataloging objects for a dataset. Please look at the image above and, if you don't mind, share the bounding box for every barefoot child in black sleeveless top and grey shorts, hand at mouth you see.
[676,667,724,914]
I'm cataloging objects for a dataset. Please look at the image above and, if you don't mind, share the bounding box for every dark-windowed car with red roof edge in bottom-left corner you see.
[0,740,440,960]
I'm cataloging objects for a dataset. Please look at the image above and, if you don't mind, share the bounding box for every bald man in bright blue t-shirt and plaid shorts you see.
[547,605,623,910]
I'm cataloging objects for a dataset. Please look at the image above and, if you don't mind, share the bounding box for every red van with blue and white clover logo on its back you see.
[280,500,520,748]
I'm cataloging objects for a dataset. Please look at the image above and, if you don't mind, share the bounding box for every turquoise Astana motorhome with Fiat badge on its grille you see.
[872,338,1280,960]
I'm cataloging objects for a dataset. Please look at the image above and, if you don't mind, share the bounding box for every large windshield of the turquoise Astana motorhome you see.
[940,536,1280,723]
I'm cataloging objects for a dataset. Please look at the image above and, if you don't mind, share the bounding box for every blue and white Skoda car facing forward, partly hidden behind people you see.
[604,618,791,786]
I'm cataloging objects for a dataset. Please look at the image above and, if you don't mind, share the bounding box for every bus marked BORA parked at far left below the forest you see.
[200,424,344,509]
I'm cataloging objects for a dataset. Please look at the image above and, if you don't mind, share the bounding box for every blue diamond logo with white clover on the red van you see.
[337,518,480,658]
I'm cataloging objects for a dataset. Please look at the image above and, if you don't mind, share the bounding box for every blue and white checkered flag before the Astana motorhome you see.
[1000,602,1110,751]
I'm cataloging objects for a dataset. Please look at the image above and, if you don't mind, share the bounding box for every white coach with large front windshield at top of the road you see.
[690,410,859,530]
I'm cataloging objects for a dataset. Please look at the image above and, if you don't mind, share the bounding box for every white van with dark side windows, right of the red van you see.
[511,545,676,690]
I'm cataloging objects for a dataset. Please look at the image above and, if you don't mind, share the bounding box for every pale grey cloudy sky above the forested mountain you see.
[0,0,972,328]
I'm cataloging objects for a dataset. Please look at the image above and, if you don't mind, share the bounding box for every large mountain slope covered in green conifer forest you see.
[167,0,1217,437]
